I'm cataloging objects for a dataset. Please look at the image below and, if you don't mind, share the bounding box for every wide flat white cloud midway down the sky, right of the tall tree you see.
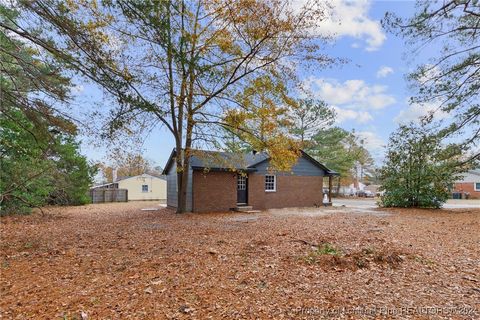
[305,78,396,110]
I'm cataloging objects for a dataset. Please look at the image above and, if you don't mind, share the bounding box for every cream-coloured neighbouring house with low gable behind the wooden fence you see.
[92,173,167,200]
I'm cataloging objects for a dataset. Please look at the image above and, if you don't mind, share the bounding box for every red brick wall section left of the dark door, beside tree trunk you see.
[193,171,237,212]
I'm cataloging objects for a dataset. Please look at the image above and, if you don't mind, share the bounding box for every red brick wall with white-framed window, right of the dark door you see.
[248,173,323,210]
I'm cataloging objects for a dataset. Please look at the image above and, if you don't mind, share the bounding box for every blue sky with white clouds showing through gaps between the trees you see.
[76,0,425,166]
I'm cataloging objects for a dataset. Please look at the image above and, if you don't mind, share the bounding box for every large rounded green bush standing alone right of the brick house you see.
[380,123,460,208]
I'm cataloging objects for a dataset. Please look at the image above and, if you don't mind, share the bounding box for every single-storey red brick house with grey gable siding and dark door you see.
[163,149,338,212]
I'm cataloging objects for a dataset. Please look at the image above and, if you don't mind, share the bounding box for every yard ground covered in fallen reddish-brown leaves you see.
[0,202,480,319]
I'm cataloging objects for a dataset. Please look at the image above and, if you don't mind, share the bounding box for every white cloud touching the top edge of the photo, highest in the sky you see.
[293,0,387,51]
